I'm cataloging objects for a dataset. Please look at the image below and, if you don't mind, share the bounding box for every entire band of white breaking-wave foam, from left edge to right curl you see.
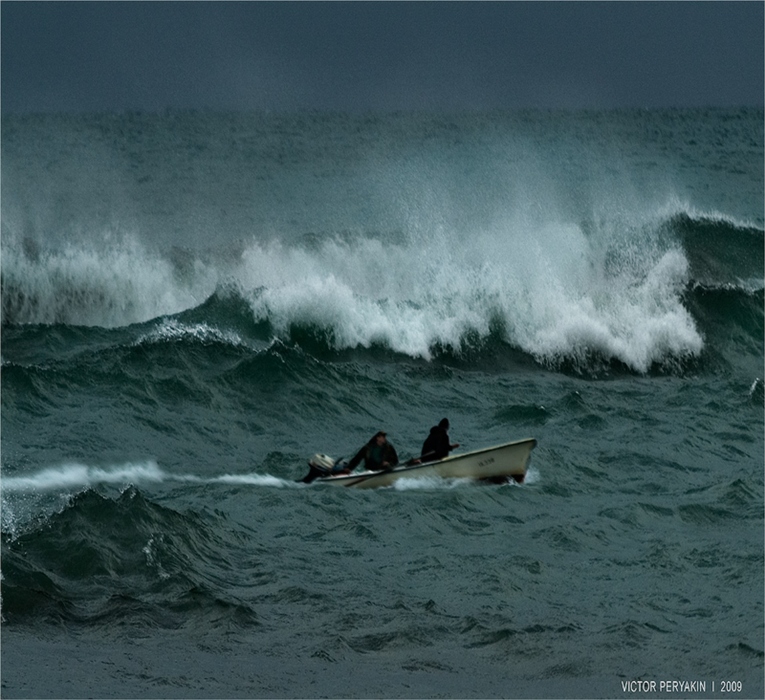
[3,197,703,372]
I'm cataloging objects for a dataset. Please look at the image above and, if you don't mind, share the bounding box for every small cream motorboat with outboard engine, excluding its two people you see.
[302,438,537,488]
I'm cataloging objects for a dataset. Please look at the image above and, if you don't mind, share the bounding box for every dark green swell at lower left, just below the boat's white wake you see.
[2,488,258,628]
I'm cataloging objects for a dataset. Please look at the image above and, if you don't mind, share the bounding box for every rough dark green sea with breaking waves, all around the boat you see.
[0,109,765,698]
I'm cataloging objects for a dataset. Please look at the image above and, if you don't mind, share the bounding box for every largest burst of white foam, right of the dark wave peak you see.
[235,208,703,372]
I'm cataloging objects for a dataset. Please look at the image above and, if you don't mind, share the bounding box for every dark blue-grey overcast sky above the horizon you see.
[0,0,765,114]
